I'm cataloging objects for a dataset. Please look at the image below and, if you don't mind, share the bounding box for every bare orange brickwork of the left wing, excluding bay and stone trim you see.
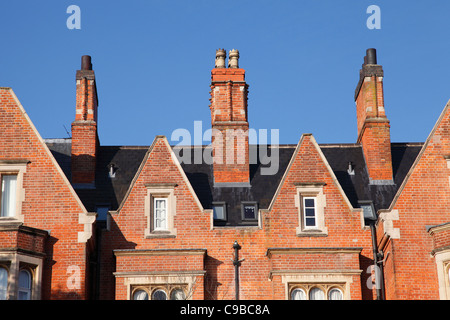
[0,88,92,299]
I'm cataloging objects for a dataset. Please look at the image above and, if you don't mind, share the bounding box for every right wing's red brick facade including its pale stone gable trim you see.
[378,99,450,299]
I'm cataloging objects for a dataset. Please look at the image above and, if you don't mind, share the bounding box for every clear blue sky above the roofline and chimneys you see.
[0,0,450,145]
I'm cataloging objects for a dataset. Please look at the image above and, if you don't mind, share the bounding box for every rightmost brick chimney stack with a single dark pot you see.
[355,48,393,184]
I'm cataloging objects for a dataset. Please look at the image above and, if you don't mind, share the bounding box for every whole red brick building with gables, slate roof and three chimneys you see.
[0,49,450,300]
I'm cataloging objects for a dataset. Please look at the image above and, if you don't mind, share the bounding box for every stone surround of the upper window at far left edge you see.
[0,160,29,224]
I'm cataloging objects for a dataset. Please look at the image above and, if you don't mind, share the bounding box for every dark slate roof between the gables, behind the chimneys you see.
[45,139,423,225]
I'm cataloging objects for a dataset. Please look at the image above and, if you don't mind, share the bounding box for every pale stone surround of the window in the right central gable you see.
[294,182,328,237]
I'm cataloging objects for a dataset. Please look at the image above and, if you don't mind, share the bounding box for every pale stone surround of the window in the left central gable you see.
[144,183,177,238]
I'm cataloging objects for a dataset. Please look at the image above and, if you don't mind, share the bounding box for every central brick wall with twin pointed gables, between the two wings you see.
[100,136,373,299]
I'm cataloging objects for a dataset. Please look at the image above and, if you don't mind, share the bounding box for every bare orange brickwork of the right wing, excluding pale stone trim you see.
[384,101,450,300]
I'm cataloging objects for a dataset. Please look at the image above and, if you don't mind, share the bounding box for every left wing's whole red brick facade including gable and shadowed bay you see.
[0,88,94,299]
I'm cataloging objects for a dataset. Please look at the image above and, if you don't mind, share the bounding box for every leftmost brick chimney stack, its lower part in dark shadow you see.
[71,56,99,185]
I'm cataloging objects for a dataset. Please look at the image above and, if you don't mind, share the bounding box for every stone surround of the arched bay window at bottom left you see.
[0,251,43,300]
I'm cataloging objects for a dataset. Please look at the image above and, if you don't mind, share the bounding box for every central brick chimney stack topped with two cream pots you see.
[210,49,250,186]
